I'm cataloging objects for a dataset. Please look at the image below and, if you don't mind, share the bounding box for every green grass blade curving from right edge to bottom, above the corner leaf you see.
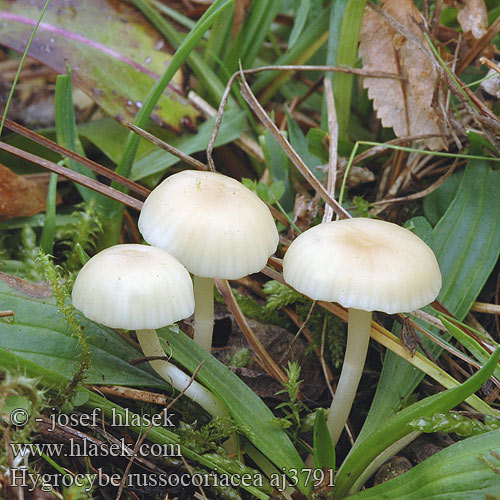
[335,348,500,500]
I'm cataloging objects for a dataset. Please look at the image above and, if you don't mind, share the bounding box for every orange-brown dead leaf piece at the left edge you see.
[0,164,57,220]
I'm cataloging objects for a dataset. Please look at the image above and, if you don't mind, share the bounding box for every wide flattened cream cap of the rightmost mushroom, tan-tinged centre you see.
[283,218,441,314]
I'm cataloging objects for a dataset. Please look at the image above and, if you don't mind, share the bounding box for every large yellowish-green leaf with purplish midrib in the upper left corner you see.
[0,0,199,131]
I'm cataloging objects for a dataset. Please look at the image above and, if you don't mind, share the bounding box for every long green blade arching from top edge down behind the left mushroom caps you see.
[99,0,234,247]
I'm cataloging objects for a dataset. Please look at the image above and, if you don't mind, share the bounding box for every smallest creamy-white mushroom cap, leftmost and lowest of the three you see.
[72,245,194,330]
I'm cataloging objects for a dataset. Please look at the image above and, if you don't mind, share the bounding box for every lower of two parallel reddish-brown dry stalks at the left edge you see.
[0,142,143,210]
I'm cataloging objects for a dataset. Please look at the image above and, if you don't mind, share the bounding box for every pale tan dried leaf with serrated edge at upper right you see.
[359,0,444,149]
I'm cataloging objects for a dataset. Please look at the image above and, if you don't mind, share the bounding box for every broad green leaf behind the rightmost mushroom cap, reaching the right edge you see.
[358,147,500,441]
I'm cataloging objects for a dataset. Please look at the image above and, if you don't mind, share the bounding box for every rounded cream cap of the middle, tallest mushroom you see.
[139,170,278,279]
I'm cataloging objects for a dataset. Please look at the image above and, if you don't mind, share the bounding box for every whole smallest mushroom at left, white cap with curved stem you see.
[72,244,234,432]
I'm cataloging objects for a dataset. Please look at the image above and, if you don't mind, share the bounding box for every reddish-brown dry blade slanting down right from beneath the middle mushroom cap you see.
[214,279,287,383]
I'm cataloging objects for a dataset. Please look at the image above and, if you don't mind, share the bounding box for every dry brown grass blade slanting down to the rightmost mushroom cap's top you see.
[240,72,351,219]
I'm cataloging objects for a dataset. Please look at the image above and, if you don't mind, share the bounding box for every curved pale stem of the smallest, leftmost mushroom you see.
[136,330,225,417]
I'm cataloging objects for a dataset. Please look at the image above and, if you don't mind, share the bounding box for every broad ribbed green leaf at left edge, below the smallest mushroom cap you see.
[0,273,162,388]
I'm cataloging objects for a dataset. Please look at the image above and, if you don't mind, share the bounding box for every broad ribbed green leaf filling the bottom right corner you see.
[348,430,500,500]
